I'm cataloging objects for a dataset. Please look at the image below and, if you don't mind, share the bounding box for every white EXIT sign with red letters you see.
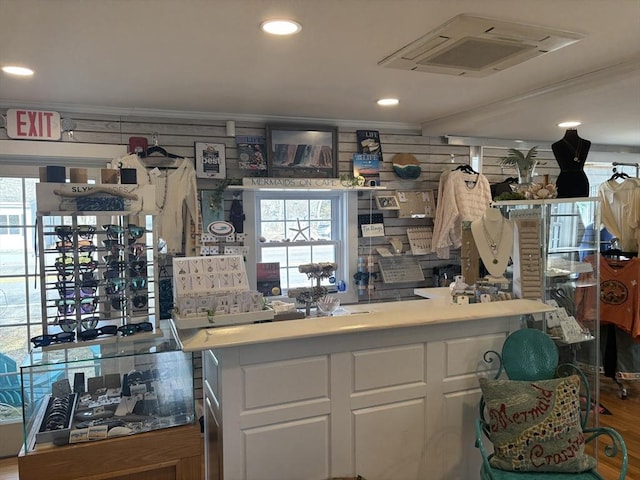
[7,108,61,140]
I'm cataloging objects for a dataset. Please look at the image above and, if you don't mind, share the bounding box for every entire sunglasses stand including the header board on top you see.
[34,183,161,349]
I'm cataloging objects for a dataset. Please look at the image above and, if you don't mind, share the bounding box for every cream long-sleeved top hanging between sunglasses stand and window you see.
[119,154,199,256]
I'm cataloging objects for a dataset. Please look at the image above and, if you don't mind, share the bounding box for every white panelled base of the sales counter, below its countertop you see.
[203,300,536,480]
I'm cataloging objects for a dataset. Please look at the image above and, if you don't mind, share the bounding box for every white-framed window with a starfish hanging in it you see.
[244,190,357,301]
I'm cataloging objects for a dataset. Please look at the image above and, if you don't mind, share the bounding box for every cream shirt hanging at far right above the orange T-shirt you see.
[598,178,640,252]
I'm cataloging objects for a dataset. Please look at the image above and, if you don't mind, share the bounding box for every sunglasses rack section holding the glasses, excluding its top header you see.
[32,203,159,349]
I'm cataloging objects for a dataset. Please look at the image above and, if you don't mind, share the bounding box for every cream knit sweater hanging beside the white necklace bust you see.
[431,170,491,258]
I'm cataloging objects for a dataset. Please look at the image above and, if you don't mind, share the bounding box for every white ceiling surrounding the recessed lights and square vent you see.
[0,0,640,151]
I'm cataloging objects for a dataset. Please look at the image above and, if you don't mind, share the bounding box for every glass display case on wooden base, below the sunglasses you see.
[20,327,195,455]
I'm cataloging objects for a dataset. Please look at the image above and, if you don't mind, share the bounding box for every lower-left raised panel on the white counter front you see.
[243,416,330,480]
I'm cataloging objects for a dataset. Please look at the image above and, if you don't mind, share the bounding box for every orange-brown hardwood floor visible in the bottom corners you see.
[0,378,640,480]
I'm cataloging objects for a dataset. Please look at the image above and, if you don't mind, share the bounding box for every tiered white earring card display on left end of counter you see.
[172,255,274,329]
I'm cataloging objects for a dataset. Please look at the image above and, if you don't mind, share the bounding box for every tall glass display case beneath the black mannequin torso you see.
[495,197,606,420]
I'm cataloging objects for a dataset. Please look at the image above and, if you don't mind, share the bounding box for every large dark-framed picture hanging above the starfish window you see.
[266,125,338,178]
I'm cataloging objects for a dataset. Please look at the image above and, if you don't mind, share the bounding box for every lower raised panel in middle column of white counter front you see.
[353,398,430,480]
